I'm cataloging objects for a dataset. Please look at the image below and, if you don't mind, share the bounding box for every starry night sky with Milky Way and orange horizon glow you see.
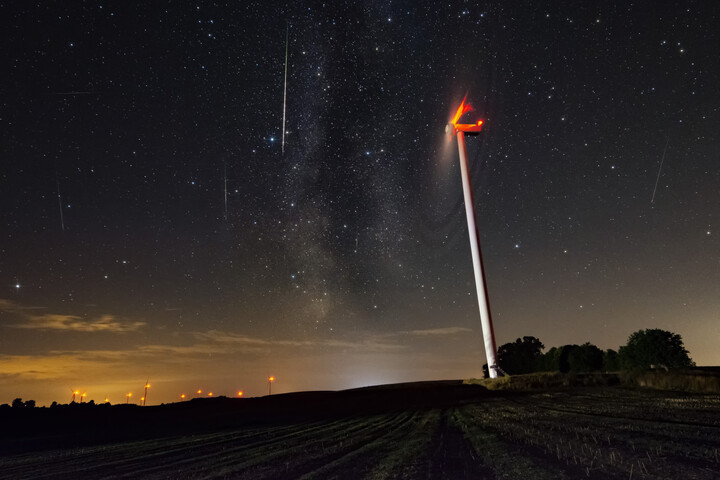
[0,1,720,404]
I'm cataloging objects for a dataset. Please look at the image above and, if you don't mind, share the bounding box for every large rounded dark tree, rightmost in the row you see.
[619,328,695,369]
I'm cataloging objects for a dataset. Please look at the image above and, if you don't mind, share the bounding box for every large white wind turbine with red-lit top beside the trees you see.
[445,98,498,378]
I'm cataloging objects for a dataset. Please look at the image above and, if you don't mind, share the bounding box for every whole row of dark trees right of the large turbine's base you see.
[498,329,695,375]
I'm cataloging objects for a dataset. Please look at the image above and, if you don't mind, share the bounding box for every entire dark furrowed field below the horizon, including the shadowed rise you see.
[0,381,720,479]
